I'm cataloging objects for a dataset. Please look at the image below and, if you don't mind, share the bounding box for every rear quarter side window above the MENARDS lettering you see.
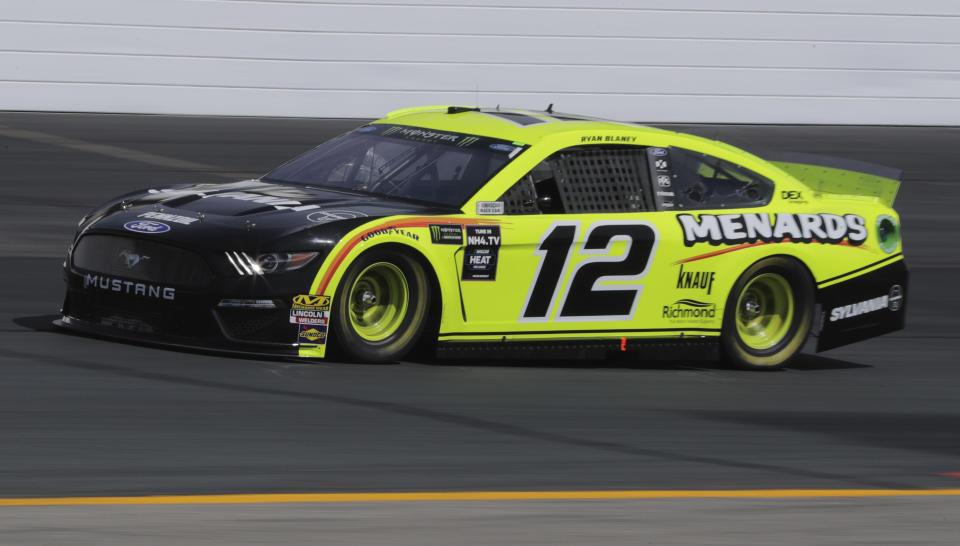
[670,148,773,210]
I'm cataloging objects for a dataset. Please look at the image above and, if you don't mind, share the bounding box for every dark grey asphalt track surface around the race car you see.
[0,113,960,544]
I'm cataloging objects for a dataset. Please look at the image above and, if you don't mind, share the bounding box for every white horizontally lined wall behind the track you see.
[0,0,960,125]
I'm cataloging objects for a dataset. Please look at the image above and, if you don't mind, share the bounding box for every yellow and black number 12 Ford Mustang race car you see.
[58,106,907,369]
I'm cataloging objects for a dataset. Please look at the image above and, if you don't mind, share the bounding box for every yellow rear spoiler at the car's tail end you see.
[754,152,903,207]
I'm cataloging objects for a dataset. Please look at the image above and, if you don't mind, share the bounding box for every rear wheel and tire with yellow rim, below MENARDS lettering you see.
[720,256,815,370]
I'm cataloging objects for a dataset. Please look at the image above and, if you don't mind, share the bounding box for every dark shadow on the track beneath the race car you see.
[13,315,873,373]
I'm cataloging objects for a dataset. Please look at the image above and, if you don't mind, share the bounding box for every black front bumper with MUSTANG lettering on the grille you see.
[57,237,322,356]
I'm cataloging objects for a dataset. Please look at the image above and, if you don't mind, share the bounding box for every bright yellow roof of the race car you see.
[374,106,680,144]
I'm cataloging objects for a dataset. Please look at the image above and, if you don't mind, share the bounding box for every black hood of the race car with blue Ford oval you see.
[82,180,459,251]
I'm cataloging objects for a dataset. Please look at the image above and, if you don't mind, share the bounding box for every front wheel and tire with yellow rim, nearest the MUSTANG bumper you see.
[331,248,431,363]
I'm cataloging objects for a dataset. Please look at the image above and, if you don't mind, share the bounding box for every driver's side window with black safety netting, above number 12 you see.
[500,146,654,214]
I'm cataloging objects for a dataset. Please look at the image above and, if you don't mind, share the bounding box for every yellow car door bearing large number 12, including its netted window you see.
[458,145,662,339]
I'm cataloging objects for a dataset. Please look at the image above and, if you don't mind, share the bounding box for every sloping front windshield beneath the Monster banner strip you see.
[264,124,526,207]
